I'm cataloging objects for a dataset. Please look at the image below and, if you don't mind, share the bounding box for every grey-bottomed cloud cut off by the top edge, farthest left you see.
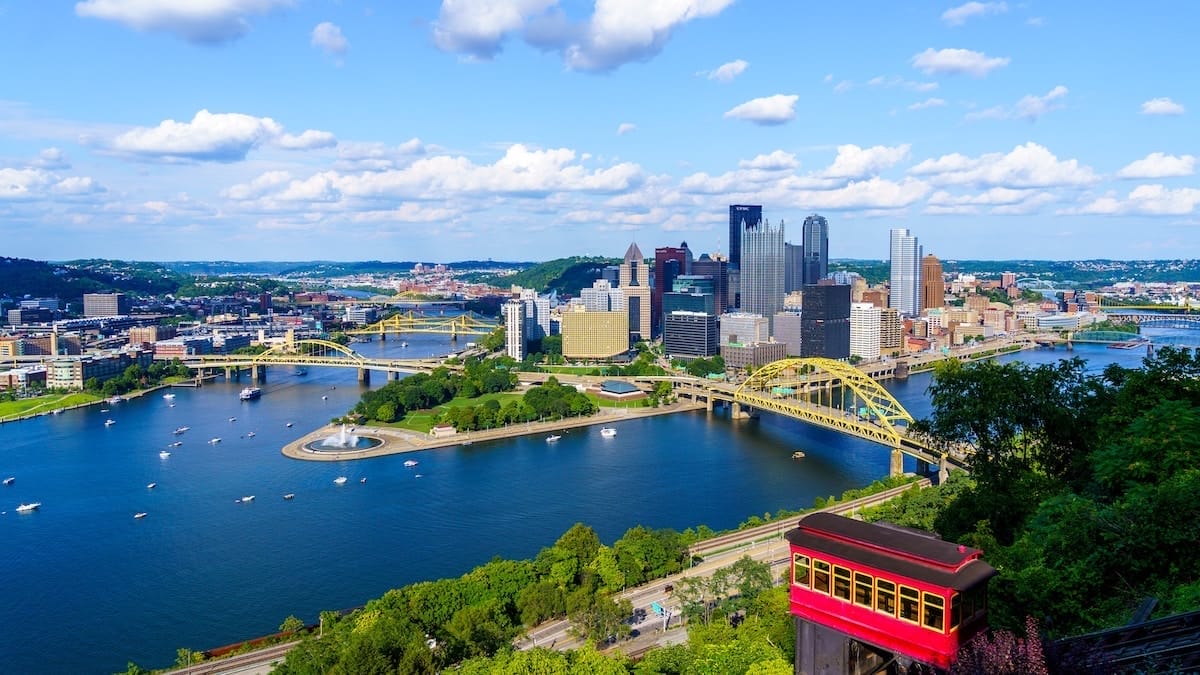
[74,0,294,44]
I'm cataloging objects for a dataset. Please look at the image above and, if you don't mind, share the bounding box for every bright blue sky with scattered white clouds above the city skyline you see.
[0,0,1200,261]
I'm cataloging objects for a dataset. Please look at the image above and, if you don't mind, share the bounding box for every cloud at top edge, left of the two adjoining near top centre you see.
[433,0,558,59]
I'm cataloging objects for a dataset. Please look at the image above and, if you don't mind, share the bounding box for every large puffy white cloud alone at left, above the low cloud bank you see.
[109,109,337,162]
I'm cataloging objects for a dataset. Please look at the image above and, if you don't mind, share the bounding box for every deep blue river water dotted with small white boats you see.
[0,336,1144,673]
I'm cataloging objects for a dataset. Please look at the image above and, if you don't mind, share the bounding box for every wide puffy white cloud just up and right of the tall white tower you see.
[908,143,1097,187]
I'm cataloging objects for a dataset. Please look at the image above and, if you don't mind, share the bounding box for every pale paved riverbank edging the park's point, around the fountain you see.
[281,401,704,461]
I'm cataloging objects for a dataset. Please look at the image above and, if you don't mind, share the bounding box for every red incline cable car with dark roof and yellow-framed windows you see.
[787,513,996,669]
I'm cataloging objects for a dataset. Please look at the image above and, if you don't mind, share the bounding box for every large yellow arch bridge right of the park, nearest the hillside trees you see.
[680,358,971,474]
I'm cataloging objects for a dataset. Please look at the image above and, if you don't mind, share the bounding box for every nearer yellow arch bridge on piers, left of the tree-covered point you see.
[181,340,442,382]
